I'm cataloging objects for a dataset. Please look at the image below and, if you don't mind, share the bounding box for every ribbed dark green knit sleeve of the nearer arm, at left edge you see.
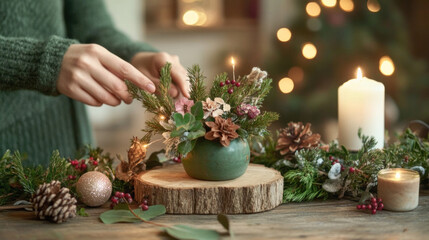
[0,35,78,95]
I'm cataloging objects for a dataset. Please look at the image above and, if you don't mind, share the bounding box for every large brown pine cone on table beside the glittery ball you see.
[30,181,77,223]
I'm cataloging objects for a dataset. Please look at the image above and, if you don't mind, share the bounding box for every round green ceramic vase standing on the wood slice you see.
[182,138,250,181]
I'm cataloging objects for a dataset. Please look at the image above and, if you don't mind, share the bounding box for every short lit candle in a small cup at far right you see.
[377,168,420,211]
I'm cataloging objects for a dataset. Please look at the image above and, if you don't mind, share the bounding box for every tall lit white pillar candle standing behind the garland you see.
[338,68,384,151]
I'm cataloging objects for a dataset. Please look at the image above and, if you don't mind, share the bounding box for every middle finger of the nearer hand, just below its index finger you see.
[91,65,133,104]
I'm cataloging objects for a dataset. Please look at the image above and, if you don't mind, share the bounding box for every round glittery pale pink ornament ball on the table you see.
[76,171,112,207]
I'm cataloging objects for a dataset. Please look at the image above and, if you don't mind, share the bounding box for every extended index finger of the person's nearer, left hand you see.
[95,46,156,93]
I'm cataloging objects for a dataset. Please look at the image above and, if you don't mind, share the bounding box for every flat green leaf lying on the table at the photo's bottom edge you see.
[163,225,220,240]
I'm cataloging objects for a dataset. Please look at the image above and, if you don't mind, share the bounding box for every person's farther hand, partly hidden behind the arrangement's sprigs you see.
[131,52,190,98]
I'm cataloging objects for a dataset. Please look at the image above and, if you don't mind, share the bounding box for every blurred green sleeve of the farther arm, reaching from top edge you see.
[64,0,156,61]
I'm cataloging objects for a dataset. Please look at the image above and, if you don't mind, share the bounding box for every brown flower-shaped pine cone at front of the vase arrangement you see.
[204,117,240,147]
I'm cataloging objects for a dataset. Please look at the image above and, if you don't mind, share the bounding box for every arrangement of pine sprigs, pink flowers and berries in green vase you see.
[127,63,278,158]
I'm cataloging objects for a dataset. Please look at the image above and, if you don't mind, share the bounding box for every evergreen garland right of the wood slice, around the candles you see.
[252,129,429,202]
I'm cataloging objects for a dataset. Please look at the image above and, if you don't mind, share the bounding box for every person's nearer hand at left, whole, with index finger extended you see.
[57,44,156,106]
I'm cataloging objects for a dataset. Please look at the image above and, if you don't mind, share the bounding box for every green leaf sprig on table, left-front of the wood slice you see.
[100,205,165,224]
